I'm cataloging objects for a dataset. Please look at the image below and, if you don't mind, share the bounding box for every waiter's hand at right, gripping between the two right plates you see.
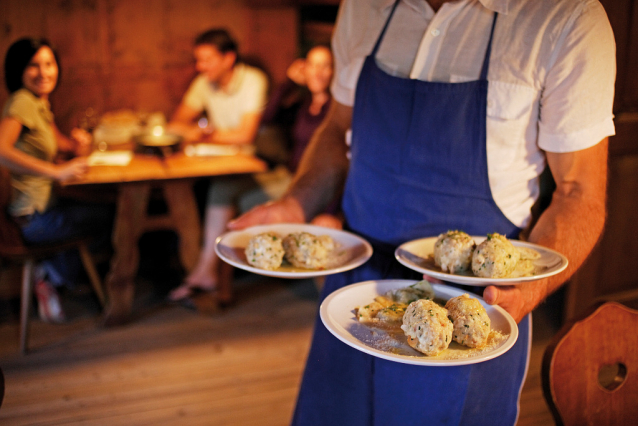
[483,280,546,323]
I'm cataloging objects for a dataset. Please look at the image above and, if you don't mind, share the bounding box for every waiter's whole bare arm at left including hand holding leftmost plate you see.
[228,100,352,229]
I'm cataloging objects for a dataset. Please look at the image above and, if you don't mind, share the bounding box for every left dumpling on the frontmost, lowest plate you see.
[401,299,453,356]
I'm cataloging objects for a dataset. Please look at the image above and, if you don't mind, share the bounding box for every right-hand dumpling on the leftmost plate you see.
[283,232,334,269]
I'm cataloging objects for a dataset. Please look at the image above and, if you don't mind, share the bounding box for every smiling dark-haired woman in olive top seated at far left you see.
[0,38,113,322]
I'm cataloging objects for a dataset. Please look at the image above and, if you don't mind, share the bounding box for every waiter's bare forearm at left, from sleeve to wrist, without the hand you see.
[287,100,352,219]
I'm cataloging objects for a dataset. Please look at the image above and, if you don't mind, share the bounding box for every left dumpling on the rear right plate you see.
[434,231,476,274]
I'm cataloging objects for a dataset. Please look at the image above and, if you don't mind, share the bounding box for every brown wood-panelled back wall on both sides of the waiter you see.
[0,0,638,317]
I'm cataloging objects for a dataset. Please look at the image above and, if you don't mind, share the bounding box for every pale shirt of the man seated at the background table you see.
[184,63,268,129]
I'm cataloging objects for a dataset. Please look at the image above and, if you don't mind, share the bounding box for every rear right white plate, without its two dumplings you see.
[394,236,568,286]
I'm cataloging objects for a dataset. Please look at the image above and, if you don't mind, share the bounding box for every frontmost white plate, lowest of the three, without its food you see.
[319,280,518,366]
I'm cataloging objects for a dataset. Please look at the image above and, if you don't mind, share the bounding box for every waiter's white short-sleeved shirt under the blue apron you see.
[331,0,616,227]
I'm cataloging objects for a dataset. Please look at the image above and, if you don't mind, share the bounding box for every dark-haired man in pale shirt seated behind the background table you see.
[167,29,268,301]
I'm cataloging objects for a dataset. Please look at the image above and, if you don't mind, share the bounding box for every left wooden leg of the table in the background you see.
[104,183,151,326]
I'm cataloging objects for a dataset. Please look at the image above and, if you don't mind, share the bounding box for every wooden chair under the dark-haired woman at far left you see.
[0,167,104,353]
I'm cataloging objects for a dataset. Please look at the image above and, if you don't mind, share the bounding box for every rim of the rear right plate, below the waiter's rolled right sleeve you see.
[394,235,569,287]
